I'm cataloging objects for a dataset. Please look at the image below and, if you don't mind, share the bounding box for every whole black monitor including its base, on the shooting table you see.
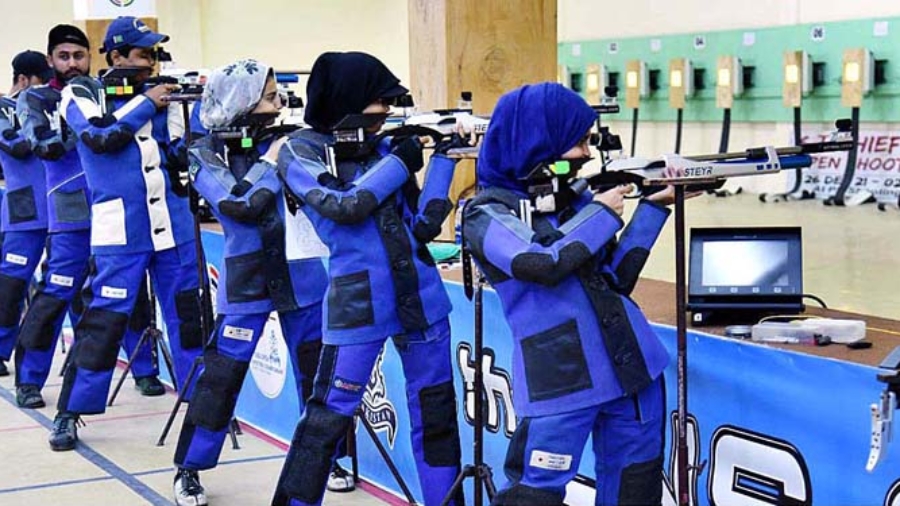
[688,227,804,325]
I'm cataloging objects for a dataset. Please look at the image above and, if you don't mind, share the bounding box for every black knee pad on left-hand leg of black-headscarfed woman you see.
[280,401,353,503]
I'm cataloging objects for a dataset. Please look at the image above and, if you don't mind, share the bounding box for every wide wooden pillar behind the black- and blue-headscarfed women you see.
[409,0,557,240]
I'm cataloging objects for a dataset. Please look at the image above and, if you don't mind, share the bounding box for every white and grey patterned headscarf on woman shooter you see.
[200,59,272,130]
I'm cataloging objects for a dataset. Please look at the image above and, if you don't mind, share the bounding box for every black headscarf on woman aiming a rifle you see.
[304,52,409,132]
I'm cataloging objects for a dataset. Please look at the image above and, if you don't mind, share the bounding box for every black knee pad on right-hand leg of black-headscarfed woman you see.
[419,381,462,467]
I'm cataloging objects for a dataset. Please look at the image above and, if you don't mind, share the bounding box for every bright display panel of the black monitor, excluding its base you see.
[688,227,803,303]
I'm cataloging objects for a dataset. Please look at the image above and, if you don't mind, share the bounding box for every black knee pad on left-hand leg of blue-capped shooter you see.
[75,308,128,371]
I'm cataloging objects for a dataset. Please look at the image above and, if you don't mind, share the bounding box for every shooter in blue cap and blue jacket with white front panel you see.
[50,17,204,450]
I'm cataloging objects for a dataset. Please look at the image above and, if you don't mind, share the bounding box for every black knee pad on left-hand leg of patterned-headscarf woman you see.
[187,349,250,431]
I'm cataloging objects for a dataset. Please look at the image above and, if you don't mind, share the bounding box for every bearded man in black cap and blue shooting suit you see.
[16,25,165,408]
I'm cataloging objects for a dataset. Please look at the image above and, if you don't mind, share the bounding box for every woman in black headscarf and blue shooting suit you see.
[272,53,462,506]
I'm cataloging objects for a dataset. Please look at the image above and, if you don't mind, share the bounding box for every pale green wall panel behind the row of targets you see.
[558,18,900,122]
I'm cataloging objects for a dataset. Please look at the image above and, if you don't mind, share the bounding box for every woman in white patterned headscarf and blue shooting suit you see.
[174,60,327,506]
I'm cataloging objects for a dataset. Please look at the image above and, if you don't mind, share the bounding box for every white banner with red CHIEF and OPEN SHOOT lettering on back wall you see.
[789,130,900,204]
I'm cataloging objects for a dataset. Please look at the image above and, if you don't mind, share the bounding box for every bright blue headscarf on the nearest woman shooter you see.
[475,83,597,194]
